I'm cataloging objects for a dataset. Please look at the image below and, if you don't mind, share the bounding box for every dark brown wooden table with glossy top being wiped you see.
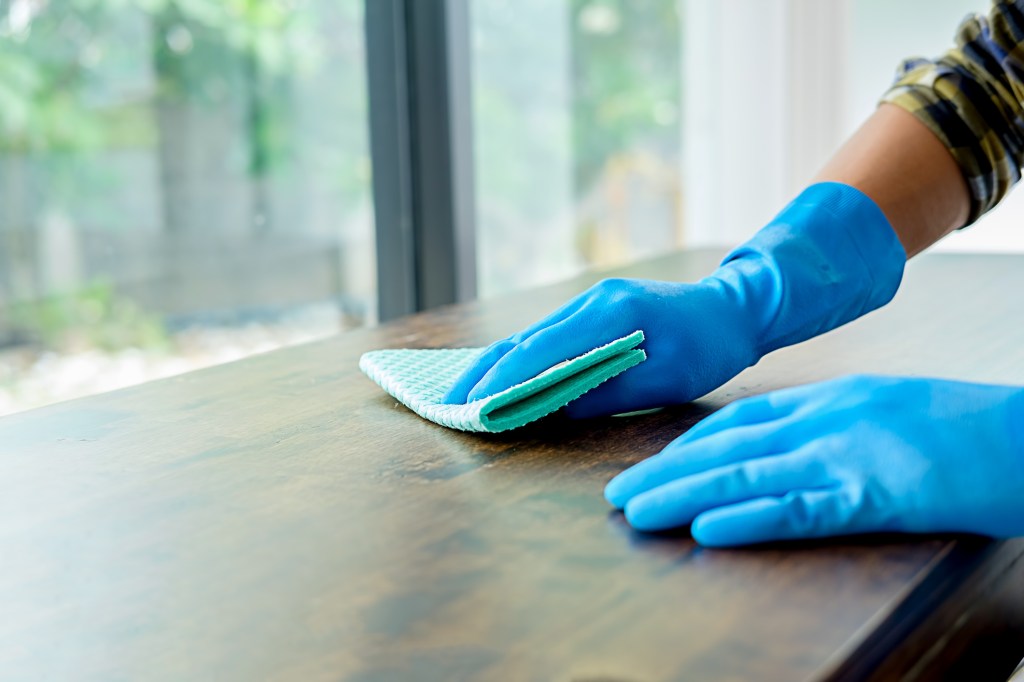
[0,252,1024,681]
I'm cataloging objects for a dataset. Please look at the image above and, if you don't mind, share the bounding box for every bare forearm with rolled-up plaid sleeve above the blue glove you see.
[816,0,1024,256]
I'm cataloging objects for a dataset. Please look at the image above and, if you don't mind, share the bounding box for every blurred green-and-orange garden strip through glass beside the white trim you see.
[570,0,682,266]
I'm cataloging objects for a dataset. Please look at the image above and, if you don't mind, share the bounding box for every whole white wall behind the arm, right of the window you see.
[681,0,1024,252]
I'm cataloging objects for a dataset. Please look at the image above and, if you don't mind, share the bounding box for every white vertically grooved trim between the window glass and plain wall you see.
[682,0,850,246]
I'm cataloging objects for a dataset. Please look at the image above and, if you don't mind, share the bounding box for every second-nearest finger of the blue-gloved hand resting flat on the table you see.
[624,453,831,530]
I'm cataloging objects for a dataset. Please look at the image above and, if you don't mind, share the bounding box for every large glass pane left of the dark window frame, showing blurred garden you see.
[0,0,375,414]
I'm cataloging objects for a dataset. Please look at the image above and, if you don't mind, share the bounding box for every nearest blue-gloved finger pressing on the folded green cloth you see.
[468,307,632,400]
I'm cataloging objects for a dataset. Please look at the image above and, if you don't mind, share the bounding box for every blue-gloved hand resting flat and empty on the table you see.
[604,376,1024,546]
